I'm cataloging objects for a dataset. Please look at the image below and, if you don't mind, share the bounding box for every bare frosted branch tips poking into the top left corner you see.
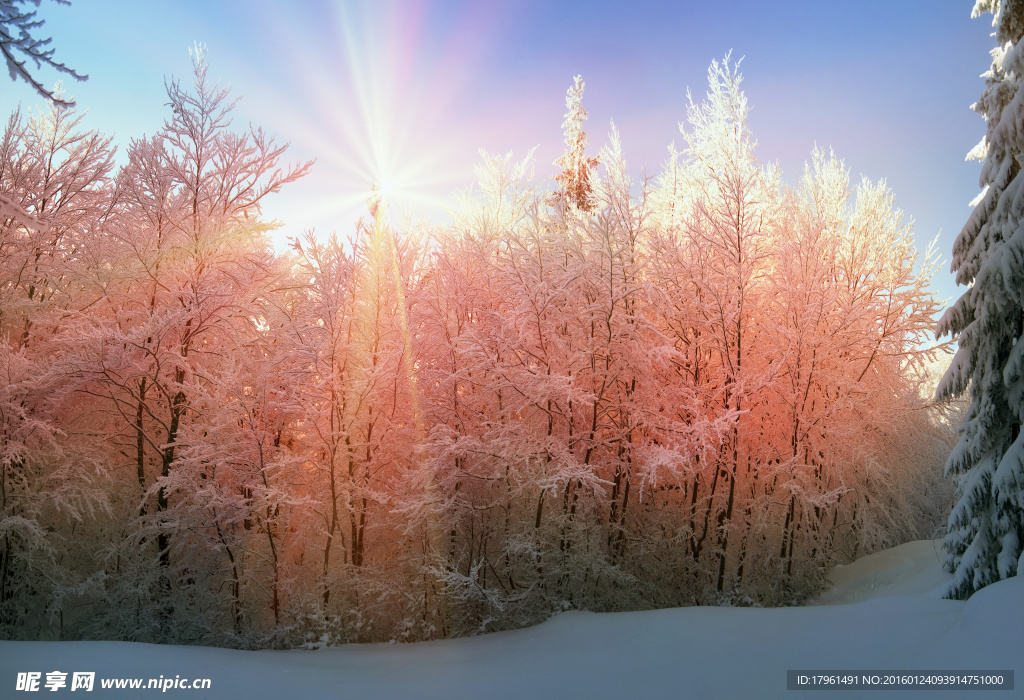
[0,0,88,106]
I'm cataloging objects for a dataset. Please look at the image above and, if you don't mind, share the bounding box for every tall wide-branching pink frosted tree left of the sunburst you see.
[54,51,305,640]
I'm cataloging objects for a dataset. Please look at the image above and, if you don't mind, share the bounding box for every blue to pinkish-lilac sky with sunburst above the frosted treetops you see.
[0,0,992,307]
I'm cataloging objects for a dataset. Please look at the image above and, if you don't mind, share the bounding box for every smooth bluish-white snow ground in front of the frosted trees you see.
[0,541,1024,700]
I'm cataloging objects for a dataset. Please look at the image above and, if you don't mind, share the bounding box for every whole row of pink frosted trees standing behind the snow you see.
[0,50,955,647]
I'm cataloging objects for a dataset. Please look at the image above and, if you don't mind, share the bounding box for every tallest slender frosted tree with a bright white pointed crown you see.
[680,54,778,593]
